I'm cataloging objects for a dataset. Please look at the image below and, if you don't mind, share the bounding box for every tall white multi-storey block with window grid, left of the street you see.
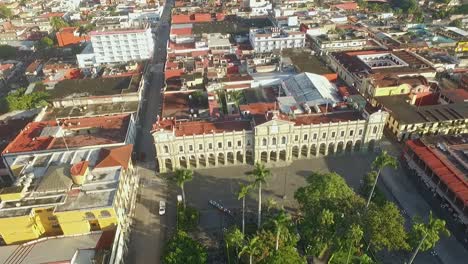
[76,28,154,68]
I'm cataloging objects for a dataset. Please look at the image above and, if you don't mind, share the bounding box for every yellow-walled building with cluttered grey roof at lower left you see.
[0,145,138,244]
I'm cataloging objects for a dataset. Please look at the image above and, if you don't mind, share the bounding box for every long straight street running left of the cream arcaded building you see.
[126,0,175,263]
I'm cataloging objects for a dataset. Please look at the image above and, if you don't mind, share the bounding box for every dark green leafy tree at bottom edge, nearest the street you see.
[161,230,208,264]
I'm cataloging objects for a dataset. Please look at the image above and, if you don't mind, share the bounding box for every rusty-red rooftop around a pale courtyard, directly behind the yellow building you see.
[3,114,131,154]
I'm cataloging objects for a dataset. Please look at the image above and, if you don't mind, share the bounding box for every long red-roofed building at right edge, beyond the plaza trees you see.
[403,134,468,225]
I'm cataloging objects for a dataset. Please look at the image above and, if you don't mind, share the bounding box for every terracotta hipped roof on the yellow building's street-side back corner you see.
[95,144,133,169]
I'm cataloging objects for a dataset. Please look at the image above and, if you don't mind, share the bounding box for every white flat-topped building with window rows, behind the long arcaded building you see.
[249,27,305,52]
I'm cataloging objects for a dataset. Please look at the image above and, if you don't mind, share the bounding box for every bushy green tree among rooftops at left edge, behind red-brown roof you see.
[6,88,49,111]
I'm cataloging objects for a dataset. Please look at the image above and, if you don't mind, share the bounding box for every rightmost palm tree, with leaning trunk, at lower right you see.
[408,212,450,264]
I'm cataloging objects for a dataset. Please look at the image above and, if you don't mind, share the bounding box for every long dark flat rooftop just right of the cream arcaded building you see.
[375,95,468,124]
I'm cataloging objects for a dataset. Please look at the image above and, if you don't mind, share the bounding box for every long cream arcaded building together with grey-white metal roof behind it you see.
[153,73,388,172]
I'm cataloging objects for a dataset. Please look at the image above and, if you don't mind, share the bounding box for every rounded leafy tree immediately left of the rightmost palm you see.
[365,202,409,251]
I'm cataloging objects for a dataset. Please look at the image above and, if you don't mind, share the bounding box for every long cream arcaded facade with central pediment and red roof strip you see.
[153,111,388,172]
